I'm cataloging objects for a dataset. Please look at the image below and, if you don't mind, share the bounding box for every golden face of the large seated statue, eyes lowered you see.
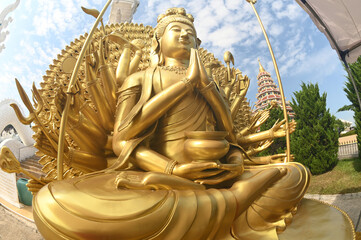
[161,22,197,60]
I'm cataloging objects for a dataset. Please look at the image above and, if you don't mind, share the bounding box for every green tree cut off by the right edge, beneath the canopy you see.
[338,57,361,157]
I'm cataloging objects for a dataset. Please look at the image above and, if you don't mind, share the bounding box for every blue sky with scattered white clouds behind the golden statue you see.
[0,0,353,125]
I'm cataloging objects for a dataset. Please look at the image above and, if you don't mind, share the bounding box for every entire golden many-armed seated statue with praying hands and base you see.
[1,8,353,240]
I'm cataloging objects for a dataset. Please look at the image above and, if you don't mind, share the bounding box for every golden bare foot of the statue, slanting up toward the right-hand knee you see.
[230,168,287,216]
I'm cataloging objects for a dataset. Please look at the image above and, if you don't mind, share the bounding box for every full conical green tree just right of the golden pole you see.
[291,83,338,174]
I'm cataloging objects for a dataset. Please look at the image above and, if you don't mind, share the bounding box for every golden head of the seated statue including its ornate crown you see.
[152,8,200,65]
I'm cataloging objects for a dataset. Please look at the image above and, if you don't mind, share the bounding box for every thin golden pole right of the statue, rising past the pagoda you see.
[246,0,291,162]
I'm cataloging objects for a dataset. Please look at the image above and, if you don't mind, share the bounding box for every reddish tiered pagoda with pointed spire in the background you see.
[254,59,295,119]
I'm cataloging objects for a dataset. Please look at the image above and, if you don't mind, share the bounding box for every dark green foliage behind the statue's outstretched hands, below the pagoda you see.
[259,105,286,156]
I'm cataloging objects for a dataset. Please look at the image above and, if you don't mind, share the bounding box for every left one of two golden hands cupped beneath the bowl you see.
[173,162,224,180]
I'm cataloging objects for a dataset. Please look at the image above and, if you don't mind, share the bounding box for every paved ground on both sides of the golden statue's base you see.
[0,193,361,240]
